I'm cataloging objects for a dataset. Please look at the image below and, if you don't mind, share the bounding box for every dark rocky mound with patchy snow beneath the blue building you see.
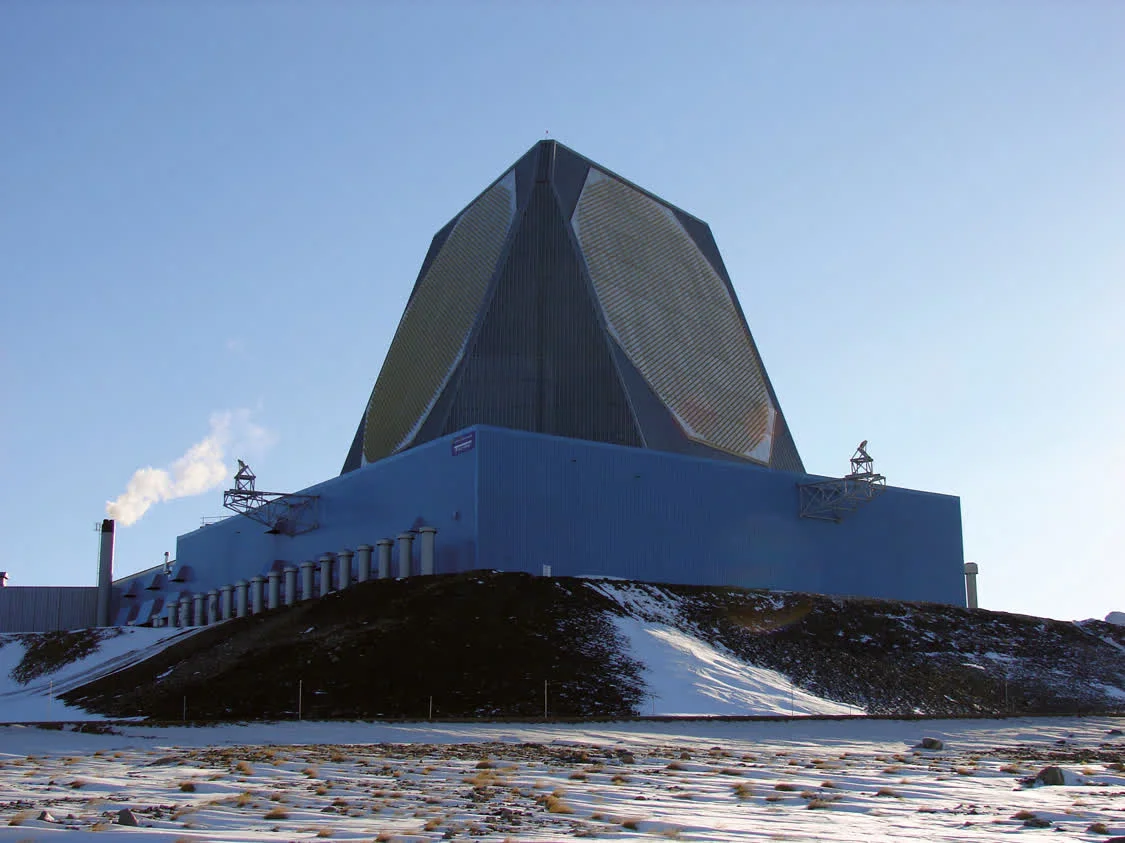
[64,572,1125,720]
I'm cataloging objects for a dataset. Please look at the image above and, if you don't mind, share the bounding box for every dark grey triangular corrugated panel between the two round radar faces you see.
[443,181,640,446]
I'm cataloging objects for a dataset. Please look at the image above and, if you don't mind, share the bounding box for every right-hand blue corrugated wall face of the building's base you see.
[478,428,964,606]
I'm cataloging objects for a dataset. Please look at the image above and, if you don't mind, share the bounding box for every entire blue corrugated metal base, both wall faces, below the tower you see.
[127,427,964,606]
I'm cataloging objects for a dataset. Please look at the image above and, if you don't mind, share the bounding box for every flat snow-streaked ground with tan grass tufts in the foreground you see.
[0,718,1125,843]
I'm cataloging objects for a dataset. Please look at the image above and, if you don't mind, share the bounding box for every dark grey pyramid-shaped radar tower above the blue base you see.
[343,141,803,472]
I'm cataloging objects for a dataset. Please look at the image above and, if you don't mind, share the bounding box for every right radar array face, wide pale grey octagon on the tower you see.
[572,169,776,464]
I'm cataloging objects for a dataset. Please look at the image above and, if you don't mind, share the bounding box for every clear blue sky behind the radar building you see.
[0,0,1125,618]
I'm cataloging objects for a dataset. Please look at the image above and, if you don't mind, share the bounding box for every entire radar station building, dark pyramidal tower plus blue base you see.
[114,141,965,624]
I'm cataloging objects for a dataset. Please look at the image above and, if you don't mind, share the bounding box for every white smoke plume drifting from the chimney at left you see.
[106,410,275,527]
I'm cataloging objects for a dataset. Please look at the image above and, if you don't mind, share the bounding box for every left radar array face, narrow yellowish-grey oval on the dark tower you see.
[363,172,515,463]
